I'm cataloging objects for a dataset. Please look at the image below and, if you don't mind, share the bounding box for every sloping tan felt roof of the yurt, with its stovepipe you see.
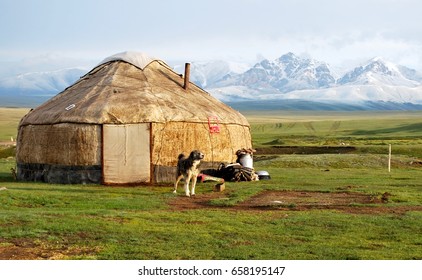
[21,52,249,126]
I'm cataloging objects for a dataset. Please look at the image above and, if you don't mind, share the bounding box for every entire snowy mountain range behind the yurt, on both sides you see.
[0,53,422,110]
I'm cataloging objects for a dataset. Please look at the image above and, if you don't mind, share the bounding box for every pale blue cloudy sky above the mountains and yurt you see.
[0,0,422,78]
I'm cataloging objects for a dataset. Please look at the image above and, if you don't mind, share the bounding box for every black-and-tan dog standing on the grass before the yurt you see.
[173,150,204,196]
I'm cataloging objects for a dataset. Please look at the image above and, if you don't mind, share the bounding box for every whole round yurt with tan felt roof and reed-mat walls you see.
[16,52,252,185]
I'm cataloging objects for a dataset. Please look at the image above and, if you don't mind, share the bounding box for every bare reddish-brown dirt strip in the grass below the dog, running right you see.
[169,191,422,214]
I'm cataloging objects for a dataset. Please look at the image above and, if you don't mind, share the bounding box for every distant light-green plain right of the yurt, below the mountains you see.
[246,112,422,146]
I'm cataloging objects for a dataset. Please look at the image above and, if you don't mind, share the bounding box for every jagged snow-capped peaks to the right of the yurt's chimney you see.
[207,53,422,104]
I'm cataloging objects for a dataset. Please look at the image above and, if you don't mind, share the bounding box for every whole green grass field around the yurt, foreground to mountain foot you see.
[0,109,422,260]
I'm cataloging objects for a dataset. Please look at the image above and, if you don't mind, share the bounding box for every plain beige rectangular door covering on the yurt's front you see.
[103,123,150,184]
